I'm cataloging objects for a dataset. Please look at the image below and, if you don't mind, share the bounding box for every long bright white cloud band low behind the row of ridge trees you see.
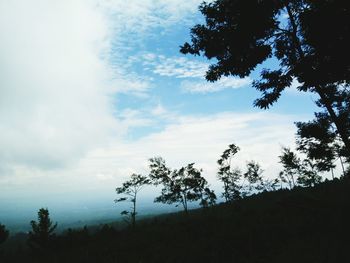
[2,110,300,195]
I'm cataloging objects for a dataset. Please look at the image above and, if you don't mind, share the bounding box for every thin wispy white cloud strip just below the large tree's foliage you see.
[181,77,252,93]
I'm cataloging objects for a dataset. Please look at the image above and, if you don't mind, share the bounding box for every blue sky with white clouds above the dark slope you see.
[0,0,322,227]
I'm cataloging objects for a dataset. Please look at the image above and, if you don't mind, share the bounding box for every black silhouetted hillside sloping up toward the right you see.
[0,179,350,263]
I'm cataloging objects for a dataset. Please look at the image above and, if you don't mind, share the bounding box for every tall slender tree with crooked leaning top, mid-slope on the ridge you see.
[217,144,242,202]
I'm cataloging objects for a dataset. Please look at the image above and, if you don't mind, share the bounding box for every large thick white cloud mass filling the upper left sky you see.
[0,0,118,172]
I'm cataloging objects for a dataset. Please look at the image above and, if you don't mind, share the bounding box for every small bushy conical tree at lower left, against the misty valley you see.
[28,208,57,249]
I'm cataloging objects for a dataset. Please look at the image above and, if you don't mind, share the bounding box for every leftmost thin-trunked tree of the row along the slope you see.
[114,174,150,228]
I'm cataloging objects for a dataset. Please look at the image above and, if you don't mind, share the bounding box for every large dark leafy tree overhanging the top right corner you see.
[180,0,350,157]
